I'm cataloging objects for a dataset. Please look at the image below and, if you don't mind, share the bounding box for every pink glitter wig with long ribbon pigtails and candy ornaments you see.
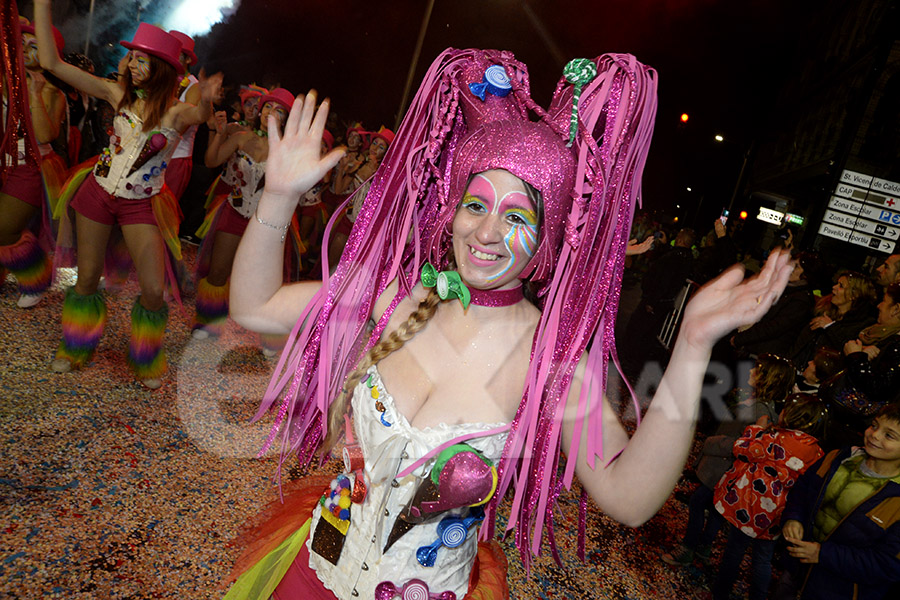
[257,49,656,567]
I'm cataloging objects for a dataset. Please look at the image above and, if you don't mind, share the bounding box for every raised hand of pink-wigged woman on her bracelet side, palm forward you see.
[265,90,345,202]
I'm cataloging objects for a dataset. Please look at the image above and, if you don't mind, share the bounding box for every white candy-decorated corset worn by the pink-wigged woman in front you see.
[307,366,507,600]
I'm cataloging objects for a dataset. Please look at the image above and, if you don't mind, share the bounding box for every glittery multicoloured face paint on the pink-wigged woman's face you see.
[461,174,538,283]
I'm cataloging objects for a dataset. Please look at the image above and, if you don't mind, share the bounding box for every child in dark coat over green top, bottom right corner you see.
[775,403,900,600]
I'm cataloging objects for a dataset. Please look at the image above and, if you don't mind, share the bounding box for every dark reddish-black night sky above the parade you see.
[19,0,816,220]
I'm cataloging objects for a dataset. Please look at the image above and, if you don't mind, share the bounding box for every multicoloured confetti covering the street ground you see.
[0,247,744,600]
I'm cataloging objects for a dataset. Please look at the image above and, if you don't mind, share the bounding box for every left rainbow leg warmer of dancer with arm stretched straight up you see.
[56,287,106,368]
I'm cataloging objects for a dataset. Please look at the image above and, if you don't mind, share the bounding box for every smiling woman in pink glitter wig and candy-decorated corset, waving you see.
[221,50,790,600]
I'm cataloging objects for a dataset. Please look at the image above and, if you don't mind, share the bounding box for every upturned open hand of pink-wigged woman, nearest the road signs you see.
[681,250,794,350]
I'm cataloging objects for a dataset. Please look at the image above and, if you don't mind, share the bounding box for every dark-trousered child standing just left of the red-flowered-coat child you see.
[660,354,795,566]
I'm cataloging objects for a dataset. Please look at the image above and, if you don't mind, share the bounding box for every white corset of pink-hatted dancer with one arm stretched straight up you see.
[94,109,180,198]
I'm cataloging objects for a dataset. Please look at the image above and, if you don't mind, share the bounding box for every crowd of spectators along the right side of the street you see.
[618,215,900,600]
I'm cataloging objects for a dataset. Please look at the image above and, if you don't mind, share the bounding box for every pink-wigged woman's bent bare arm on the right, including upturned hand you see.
[563,250,793,526]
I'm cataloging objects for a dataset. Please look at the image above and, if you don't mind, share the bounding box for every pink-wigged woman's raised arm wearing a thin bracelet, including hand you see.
[231,91,344,333]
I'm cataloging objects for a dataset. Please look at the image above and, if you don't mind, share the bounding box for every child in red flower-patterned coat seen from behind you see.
[712,394,826,600]
